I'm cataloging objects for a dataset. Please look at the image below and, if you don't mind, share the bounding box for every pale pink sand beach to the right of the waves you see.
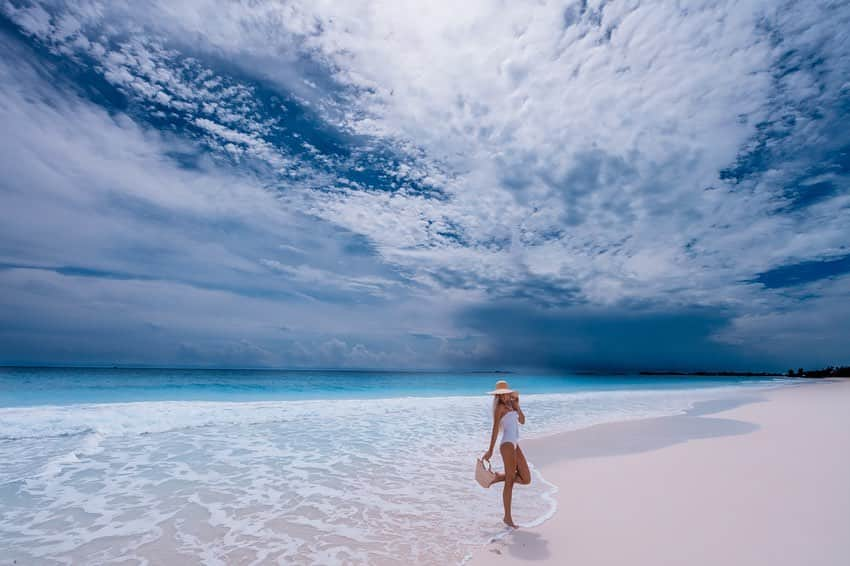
[470,380,850,566]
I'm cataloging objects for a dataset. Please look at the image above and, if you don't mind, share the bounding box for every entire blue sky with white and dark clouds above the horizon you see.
[0,0,850,369]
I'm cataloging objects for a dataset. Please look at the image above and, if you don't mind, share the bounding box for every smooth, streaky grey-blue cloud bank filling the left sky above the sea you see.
[0,31,470,367]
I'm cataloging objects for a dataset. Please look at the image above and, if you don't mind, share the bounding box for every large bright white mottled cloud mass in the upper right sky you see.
[126,1,848,310]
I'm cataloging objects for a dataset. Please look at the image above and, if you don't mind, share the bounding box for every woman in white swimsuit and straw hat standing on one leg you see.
[482,381,531,529]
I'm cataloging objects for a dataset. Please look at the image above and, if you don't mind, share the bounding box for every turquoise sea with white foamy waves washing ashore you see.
[0,368,789,564]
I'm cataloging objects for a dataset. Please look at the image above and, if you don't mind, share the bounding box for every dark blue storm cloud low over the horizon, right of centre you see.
[450,302,764,371]
